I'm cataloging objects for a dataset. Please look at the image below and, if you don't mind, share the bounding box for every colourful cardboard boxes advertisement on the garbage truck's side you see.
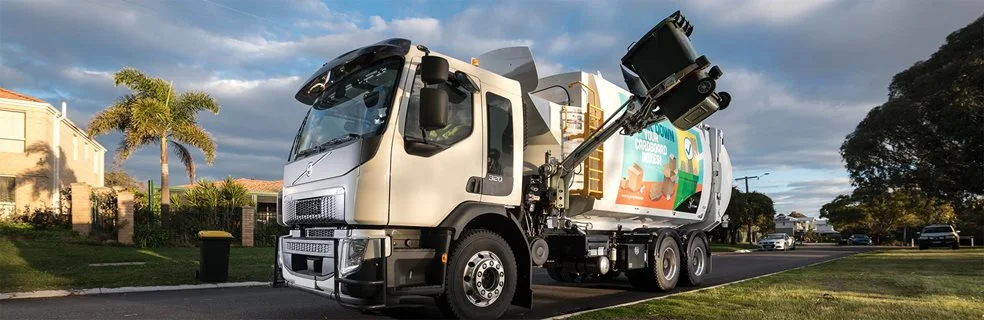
[615,115,704,213]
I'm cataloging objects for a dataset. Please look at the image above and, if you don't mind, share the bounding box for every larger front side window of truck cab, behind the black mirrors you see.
[403,73,475,146]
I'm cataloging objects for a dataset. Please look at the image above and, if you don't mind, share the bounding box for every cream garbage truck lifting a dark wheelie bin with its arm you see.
[274,11,731,319]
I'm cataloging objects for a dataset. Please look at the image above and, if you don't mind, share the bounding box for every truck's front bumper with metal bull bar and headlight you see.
[277,236,388,310]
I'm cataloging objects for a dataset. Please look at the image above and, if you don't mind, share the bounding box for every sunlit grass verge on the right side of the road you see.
[574,249,984,320]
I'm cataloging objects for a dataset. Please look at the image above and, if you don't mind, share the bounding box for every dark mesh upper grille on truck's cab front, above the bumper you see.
[283,194,345,225]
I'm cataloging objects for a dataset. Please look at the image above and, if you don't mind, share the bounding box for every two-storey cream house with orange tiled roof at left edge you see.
[0,88,106,216]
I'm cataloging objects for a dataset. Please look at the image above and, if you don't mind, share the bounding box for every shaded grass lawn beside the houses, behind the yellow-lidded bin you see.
[0,237,274,292]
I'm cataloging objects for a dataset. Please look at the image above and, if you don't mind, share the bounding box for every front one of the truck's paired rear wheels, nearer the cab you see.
[626,234,680,291]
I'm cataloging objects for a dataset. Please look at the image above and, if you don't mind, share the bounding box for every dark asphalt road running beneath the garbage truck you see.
[0,247,870,319]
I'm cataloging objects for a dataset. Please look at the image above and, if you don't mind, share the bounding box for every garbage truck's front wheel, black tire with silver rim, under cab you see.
[435,230,518,319]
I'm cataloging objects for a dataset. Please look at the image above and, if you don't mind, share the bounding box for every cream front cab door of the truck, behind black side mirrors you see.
[389,59,485,226]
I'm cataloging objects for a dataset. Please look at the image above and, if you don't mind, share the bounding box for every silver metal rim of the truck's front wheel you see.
[462,251,506,307]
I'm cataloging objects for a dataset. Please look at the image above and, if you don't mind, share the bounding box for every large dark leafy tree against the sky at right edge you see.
[840,16,984,206]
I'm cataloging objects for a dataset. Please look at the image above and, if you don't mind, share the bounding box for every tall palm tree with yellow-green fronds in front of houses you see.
[88,67,219,221]
